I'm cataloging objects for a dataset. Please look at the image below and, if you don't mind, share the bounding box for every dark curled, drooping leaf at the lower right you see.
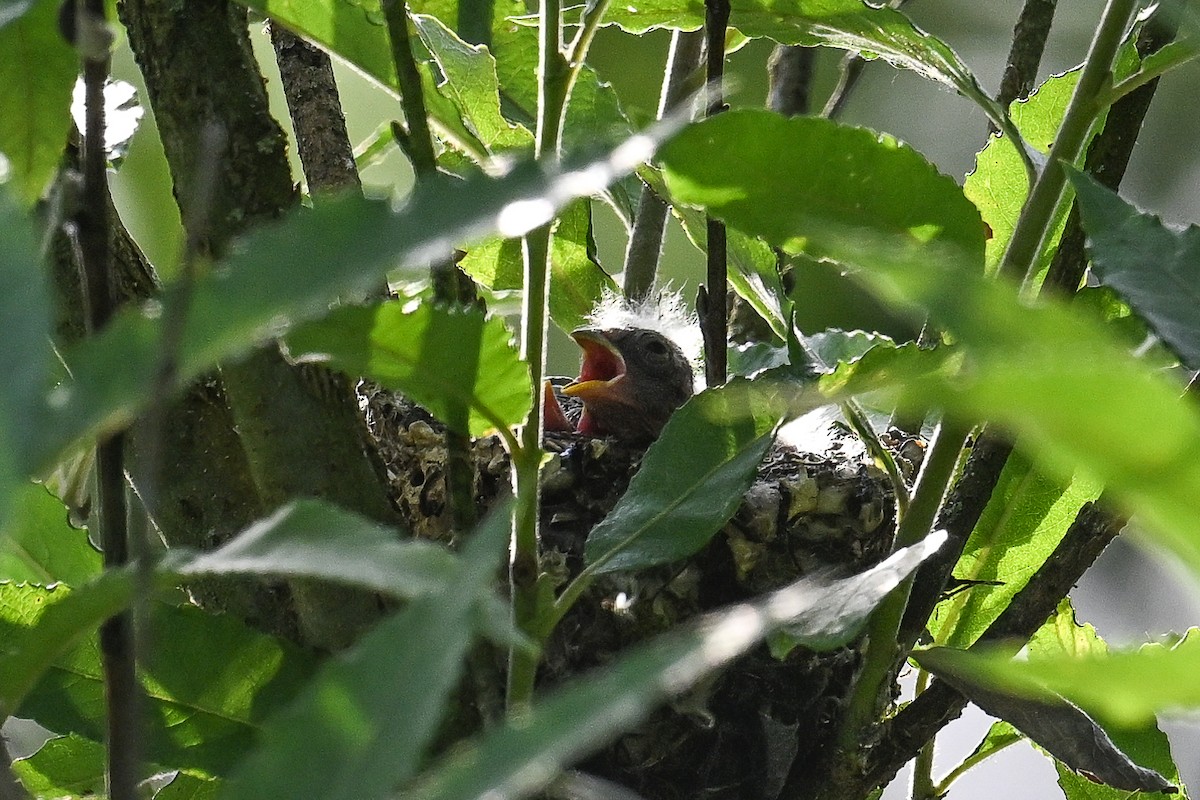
[913,648,1172,792]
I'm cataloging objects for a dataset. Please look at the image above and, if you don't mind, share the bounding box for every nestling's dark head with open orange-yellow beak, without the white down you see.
[563,327,694,443]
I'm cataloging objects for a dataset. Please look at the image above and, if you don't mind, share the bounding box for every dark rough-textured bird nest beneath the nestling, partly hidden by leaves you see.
[360,386,920,800]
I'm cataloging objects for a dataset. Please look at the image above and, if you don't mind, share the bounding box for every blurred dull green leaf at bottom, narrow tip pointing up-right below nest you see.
[223,504,509,800]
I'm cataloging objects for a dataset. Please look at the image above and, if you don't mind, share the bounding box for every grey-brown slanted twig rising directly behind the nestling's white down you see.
[624,31,704,300]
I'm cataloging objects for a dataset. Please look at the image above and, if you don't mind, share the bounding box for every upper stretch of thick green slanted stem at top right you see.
[1000,0,1138,279]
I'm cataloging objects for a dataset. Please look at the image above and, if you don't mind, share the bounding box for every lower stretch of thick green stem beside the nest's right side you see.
[839,421,971,752]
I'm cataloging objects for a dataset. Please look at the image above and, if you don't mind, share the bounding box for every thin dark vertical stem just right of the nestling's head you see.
[701,0,730,386]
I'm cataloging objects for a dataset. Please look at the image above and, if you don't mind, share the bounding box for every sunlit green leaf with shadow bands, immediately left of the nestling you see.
[286,301,532,437]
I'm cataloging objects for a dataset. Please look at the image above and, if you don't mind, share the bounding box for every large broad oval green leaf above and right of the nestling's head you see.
[660,110,984,278]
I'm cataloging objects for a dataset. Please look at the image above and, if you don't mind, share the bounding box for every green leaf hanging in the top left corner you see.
[0,0,79,203]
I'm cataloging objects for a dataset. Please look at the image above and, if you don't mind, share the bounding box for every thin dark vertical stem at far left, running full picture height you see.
[76,0,140,800]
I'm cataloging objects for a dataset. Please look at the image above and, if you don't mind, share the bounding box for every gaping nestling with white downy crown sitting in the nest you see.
[545,294,695,445]
